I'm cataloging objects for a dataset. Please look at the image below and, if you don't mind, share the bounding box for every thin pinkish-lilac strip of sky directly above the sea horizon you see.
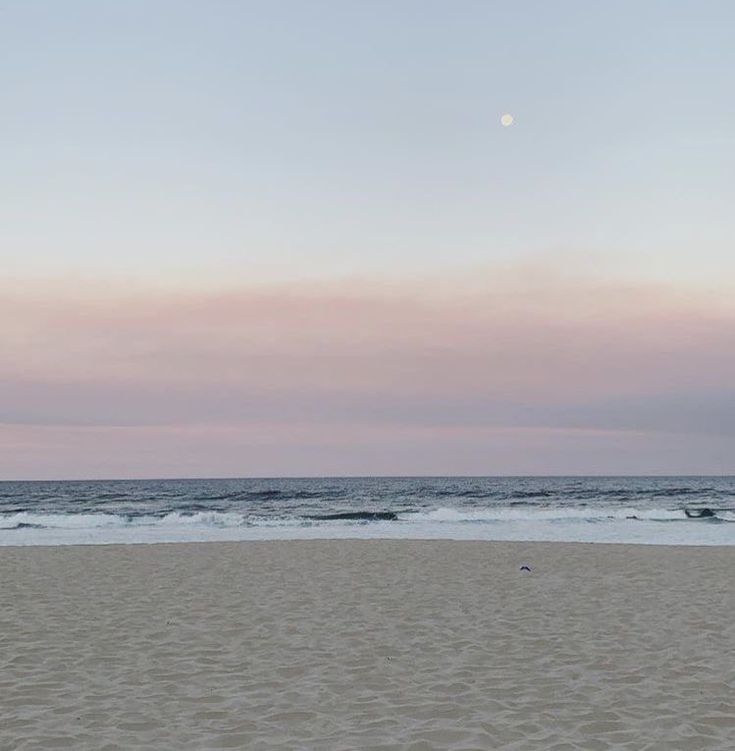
[0,425,735,479]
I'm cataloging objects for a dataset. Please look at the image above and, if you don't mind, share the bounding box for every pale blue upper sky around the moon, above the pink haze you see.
[0,0,735,279]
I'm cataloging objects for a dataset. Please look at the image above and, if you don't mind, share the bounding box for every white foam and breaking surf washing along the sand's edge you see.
[0,506,735,545]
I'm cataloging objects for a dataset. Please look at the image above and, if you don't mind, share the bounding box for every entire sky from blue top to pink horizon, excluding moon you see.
[0,0,735,479]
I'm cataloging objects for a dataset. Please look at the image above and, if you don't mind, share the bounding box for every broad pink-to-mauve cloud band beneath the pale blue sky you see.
[0,269,735,472]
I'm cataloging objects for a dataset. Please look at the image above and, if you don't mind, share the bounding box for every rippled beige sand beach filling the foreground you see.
[0,541,735,751]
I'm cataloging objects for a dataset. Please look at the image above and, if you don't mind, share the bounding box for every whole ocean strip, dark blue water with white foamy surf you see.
[0,477,735,545]
